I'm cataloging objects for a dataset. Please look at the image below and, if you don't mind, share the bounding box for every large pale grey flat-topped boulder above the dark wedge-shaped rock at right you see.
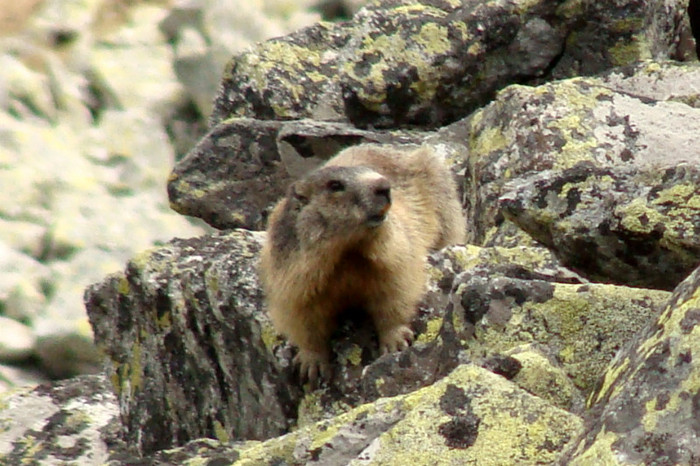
[460,67,700,249]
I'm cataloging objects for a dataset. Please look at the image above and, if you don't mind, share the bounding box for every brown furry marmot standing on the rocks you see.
[260,145,465,384]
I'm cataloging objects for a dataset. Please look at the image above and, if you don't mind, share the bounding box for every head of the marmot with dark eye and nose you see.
[287,166,391,245]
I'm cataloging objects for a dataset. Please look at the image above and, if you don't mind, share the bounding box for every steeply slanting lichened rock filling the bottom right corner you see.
[561,269,700,465]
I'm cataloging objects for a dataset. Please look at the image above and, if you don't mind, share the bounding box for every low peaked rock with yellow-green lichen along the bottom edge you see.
[134,365,582,465]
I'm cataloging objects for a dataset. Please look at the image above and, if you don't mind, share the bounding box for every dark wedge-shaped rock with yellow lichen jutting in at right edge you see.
[500,162,700,290]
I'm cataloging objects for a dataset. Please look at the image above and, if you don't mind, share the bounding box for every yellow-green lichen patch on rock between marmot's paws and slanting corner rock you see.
[470,284,669,391]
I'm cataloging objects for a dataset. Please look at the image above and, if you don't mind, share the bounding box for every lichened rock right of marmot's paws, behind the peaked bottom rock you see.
[451,264,668,394]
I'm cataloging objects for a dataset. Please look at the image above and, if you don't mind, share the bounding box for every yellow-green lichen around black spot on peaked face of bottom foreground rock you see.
[352,366,581,464]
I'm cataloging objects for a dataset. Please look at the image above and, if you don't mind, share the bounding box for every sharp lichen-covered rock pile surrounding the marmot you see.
[0,0,700,465]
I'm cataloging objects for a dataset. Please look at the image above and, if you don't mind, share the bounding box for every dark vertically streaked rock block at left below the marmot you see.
[86,230,300,453]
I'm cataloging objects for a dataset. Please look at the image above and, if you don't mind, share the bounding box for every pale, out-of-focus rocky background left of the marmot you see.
[0,0,350,392]
